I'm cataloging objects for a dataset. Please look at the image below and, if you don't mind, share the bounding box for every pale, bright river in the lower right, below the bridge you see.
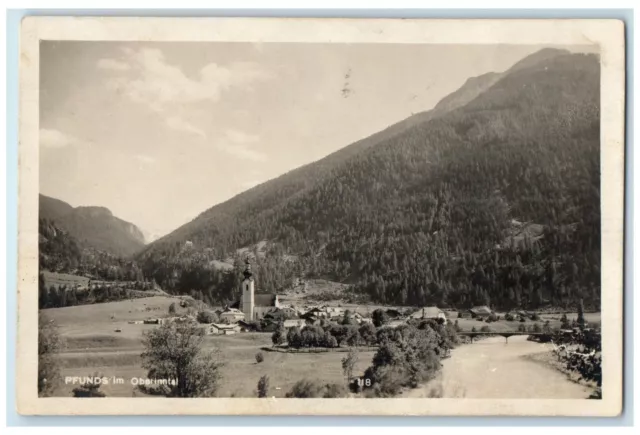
[402,336,591,399]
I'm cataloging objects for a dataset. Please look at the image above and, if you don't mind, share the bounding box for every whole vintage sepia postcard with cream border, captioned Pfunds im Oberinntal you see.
[17,17,625,416]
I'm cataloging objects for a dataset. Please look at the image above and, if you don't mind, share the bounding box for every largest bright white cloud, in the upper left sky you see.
[98,47,271,138]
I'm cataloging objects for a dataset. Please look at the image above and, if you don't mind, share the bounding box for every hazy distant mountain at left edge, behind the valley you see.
[39,195,144,256]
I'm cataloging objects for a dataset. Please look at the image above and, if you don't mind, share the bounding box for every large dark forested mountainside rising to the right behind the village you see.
[138,50,600,309]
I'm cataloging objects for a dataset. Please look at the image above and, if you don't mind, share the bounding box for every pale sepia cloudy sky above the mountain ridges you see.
[40,41,592,238]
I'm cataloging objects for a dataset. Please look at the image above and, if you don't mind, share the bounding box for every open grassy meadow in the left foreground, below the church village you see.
[44,297,373,397]
